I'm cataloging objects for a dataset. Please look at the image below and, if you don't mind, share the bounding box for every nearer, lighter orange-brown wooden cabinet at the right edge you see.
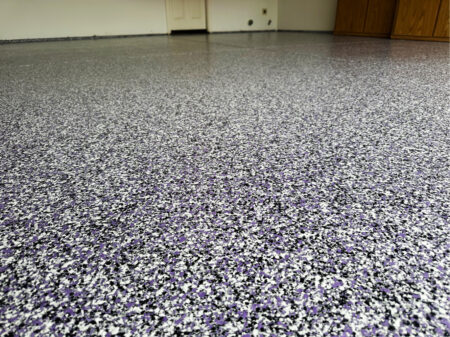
[391,0,449,41]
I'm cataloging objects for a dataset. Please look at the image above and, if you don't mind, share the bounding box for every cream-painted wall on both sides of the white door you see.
[0,0,337,40]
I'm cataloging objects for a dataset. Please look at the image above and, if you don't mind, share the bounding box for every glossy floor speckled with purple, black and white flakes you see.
[0,33,450,337]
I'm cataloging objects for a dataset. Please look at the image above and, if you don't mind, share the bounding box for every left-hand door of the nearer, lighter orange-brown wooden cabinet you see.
[393,0,441,37]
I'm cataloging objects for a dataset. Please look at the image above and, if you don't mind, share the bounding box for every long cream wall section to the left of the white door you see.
[0,0,167,40]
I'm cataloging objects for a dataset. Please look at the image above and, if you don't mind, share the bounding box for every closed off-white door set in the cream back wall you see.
[166,0,206,31]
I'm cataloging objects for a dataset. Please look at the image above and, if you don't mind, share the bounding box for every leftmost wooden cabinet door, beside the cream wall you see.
[335,0,368,33]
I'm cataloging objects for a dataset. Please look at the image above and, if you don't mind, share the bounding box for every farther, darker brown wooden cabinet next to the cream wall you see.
[334,0,396,37]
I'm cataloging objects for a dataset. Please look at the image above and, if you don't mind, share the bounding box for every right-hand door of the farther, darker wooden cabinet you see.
[364,0,396,36]
